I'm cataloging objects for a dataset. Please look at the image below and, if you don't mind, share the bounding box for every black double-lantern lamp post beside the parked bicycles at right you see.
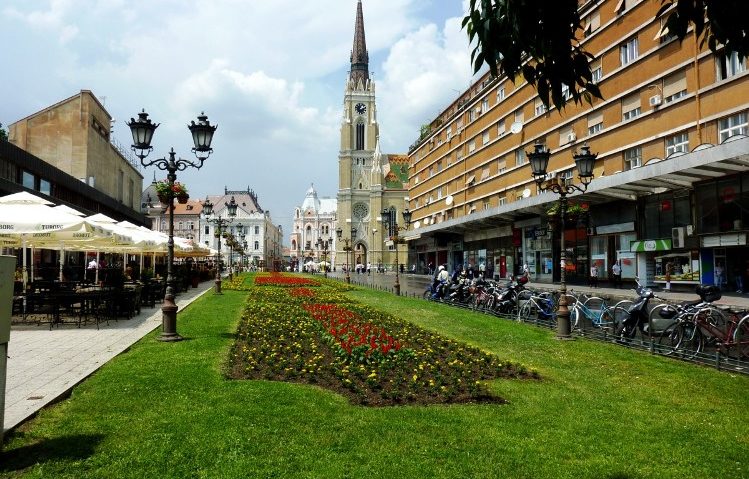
[526,143,598,339]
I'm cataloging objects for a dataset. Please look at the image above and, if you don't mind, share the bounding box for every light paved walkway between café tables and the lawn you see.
[3,281,214,431]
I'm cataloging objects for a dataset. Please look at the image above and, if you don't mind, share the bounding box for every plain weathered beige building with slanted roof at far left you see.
[8,90,143,211]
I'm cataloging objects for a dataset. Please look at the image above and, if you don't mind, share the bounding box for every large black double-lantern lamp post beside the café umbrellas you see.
[127,110,217,341]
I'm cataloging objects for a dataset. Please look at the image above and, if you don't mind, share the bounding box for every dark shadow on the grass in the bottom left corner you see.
[0,434,104,472]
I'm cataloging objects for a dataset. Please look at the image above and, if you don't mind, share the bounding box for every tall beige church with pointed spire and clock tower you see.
[336,1,408,269]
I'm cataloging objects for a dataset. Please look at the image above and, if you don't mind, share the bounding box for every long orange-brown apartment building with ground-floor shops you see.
[407,0,749,287]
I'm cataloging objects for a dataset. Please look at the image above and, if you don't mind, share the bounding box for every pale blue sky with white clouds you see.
[0,0,480,243]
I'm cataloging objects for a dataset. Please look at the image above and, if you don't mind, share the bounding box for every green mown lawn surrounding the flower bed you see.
[0,276,749,479]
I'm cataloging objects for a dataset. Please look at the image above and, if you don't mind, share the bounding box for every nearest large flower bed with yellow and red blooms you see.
[230,281,538,406]
